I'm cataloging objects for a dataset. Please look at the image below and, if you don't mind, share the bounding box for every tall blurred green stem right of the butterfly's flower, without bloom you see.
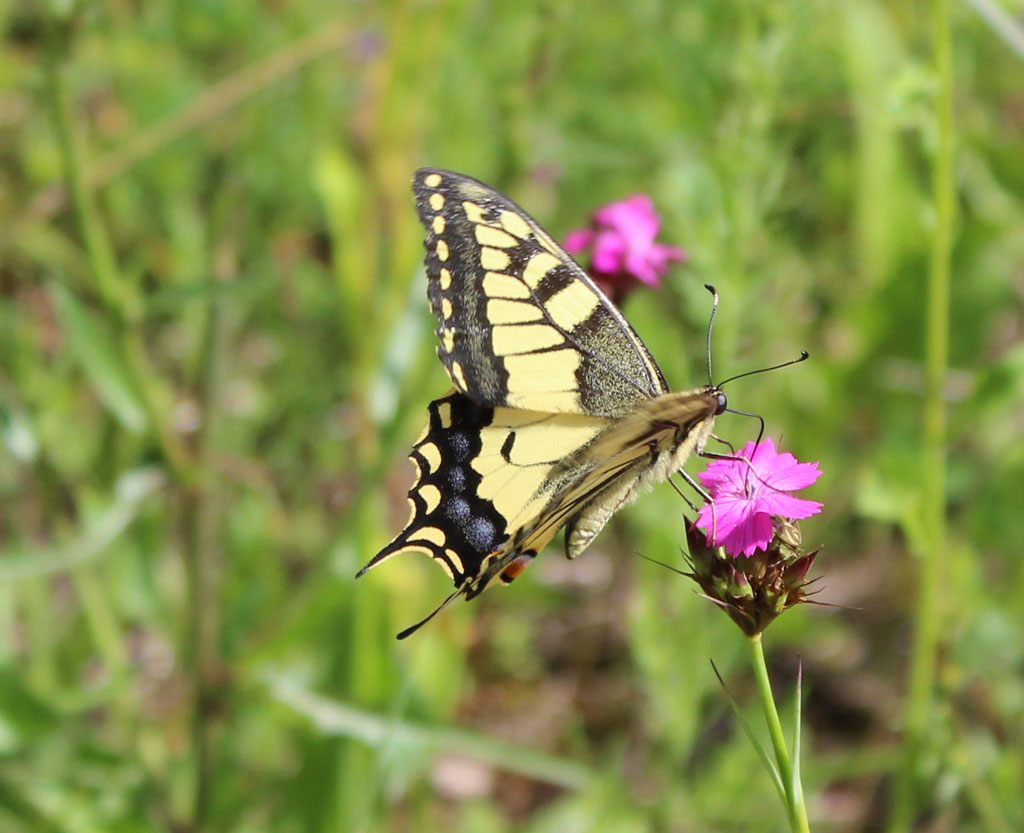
[889,0,955,833]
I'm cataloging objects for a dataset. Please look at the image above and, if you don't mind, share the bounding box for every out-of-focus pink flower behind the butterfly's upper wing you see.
[565,194,686,287]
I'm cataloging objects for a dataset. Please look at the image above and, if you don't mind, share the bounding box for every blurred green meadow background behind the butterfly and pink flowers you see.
[0,0,1024,833]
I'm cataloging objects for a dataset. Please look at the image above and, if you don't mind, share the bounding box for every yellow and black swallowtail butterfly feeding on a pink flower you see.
[357,168,726,639]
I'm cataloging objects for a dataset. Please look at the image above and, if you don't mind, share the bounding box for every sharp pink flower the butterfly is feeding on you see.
[696,438,821,556]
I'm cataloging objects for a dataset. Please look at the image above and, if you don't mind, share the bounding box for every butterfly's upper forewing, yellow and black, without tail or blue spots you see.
[413,169,668,417]
